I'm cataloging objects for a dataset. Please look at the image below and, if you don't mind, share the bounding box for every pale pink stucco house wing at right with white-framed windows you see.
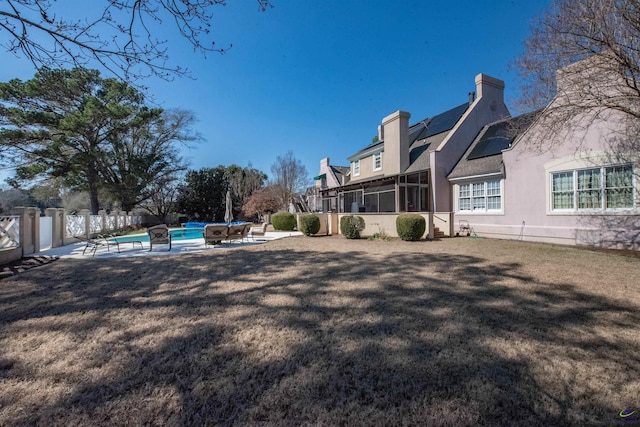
[448,56,640,249]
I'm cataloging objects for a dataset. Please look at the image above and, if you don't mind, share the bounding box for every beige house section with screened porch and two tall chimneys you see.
[316,74,509,231]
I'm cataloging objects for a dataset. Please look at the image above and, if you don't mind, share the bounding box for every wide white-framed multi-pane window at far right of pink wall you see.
[551,165,634,210]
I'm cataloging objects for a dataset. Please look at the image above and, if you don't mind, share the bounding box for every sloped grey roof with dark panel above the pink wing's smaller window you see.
[448,110,541,179]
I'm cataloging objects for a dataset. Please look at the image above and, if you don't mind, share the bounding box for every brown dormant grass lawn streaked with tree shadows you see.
[0,237,640,426]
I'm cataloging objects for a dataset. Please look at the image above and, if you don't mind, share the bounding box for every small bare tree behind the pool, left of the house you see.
[270,151,309,209]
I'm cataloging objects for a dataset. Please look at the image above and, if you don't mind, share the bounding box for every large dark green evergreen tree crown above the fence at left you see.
[0,68,197,213]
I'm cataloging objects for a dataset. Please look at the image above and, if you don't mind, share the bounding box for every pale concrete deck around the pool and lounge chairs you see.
[27,231,302,259]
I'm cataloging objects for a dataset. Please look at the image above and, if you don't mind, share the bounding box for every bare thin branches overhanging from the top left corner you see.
[0,0,272,79]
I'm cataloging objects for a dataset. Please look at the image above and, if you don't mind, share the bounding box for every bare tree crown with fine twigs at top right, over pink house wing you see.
[517,0,640,122]
